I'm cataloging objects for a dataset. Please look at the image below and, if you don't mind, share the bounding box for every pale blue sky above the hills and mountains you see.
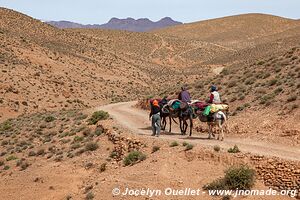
[0,0,300,24]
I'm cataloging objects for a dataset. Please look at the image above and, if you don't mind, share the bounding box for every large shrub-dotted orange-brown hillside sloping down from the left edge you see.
[0,8,195,120]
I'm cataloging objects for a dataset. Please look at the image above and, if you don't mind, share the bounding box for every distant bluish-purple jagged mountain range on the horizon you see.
[46,17,182,32]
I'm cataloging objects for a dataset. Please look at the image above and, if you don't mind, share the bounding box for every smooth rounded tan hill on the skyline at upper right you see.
[155,14,299,47]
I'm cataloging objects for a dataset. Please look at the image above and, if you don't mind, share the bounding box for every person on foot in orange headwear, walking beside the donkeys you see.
[149,100,160,137]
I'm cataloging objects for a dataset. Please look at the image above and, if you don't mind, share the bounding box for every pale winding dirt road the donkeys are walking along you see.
[96,101,300,161]
